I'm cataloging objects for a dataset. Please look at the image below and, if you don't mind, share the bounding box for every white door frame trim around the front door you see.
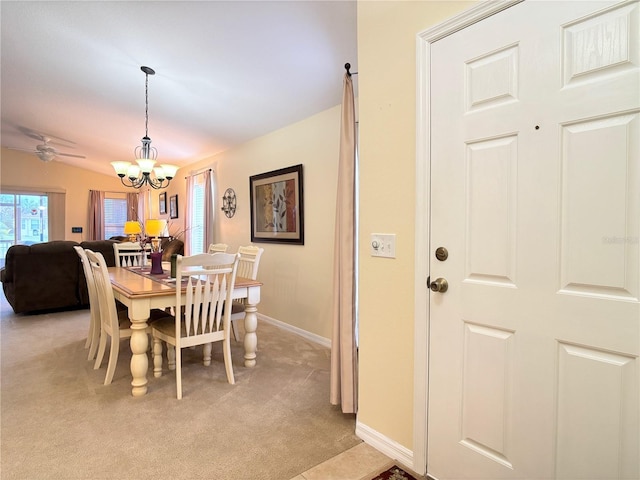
[412,0,523,474]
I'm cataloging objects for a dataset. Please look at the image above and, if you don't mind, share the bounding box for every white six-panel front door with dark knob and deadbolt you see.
[427,1,640,480]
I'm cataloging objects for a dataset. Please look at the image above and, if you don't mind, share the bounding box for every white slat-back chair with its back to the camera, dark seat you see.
[151,253,239,399]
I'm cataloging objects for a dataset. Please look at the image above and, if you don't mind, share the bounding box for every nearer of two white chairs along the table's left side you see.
[85,250,151,385]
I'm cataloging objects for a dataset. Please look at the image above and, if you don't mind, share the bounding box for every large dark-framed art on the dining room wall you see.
[249,165,304,245]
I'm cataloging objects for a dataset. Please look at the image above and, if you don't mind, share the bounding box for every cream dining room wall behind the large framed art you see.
[152,106,340,339]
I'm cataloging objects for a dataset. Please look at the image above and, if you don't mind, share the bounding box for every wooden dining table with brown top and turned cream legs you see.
[108,267,262,397]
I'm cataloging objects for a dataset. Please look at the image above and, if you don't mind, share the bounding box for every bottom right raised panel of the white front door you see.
[556,343,638,479]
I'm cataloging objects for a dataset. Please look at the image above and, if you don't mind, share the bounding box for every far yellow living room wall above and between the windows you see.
[0,148,131,242]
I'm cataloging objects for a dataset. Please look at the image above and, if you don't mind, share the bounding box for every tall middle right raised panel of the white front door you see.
[560,112,640,301]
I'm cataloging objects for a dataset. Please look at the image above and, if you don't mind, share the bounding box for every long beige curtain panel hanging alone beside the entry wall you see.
[330,73,358,413]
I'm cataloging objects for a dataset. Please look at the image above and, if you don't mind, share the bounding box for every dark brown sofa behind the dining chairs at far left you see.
[0,240,115,313]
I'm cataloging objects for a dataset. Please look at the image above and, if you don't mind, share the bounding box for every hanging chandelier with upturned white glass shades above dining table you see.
[111,66,178,189]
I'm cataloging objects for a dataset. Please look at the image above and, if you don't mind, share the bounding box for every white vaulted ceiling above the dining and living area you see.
[0,0,357,174]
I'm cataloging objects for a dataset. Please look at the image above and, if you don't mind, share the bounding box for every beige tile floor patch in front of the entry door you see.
[291,442,425,480]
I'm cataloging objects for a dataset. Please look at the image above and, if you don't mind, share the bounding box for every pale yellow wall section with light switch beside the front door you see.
[357,0,473,449]
